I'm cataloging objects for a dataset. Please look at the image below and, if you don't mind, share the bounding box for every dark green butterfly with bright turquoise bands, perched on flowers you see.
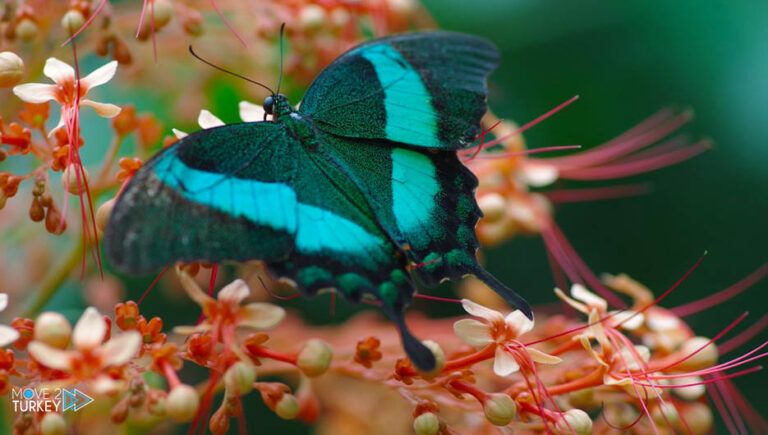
[105,31,532,371]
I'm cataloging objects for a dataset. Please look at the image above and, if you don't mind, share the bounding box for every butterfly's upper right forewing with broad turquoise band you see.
[299,32,498,150]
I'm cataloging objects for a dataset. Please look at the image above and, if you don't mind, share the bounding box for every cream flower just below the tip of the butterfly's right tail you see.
[453,299,561,376]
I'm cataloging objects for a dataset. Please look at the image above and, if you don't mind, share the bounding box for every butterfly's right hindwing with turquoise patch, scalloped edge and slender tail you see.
[324,135,531,316]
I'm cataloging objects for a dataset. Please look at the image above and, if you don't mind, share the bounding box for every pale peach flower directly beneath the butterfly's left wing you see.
[174,269,285,335]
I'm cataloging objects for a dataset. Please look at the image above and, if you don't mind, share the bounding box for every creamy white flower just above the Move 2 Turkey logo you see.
[27,307,141,377]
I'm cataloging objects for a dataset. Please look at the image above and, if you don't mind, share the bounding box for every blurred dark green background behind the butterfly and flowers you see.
[21,0,768,433]
